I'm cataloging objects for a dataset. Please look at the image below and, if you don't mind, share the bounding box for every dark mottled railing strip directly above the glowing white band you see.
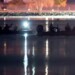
[0,11,75,16]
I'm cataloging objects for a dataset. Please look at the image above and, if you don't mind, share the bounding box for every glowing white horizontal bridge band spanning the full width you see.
[0,15,75,20]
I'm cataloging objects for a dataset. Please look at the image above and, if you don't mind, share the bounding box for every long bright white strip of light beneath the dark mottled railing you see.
[0,14,75,19]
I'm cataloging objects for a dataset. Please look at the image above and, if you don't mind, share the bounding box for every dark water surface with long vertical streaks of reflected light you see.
[0,34,75,75]
